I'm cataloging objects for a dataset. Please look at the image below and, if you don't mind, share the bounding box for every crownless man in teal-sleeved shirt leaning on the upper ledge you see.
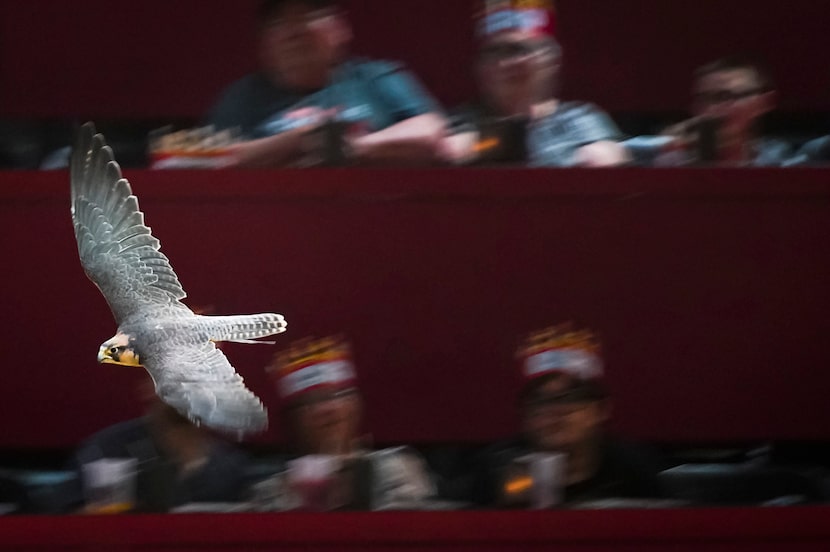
[207,0,445,167]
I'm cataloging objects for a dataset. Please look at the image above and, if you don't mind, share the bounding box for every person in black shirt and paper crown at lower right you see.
[472,325,663,506]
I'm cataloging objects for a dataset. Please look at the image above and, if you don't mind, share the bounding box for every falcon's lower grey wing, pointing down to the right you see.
[144,342,268,432]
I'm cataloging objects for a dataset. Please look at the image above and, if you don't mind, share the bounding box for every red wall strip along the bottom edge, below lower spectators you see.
[0,506,830,552]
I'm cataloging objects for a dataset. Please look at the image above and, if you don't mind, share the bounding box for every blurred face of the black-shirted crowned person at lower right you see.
[524,378,608,451]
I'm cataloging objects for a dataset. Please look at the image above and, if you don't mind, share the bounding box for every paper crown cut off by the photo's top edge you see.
[476,0,556,38]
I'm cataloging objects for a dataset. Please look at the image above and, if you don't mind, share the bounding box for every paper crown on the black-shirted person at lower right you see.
[516,323,603,381]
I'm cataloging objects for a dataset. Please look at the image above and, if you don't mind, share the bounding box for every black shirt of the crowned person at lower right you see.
[472,437,666,506]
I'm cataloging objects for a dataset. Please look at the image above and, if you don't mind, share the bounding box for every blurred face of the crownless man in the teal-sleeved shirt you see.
[260,0,351,89]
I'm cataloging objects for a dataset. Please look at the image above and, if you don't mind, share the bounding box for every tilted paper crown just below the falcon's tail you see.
[269,336,357,399]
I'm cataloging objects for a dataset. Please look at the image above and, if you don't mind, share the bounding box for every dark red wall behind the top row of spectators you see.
[0,0,830,118]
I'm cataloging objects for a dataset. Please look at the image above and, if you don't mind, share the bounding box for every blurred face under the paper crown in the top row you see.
[478,31,559,116]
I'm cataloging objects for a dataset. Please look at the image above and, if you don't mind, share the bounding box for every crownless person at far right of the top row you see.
[626,57,793,166]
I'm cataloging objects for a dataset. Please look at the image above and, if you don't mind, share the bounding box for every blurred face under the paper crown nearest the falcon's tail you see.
[291,389,361,454]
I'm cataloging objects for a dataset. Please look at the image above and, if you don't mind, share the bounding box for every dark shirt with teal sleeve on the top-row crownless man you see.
[206,59,439,138]
